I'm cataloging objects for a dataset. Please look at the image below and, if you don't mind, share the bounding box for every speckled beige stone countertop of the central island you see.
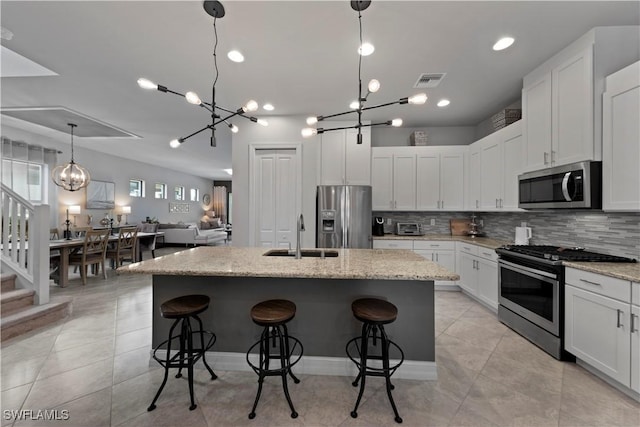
[117,246,460,281]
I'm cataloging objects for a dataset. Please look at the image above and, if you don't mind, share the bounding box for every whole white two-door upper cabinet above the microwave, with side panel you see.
[522,26,640,171]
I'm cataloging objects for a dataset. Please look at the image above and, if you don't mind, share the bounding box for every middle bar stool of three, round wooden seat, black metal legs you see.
[247,299,303,420]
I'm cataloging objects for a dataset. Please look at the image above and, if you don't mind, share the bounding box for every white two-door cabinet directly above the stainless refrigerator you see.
[320,128,371,185]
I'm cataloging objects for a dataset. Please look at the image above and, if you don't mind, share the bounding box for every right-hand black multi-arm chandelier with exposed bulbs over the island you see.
[302,1,427,144]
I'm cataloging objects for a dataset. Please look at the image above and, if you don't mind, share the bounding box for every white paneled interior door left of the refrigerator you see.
[254,149,298,247]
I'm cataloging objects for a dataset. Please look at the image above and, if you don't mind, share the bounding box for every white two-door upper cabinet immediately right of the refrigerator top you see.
[371,147,416,210]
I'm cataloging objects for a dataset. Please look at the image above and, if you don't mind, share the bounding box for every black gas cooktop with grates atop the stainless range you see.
[496,245,638,262]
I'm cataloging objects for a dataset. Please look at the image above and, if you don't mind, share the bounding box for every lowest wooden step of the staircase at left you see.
[0,298,72,341]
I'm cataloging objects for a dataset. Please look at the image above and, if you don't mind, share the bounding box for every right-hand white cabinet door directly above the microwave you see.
[551,46,594,166]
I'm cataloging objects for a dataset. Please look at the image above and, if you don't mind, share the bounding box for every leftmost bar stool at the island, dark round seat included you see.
[147,295,218,411]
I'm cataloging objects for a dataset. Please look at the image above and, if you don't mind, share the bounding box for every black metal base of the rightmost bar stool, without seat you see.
[346,323,404,423]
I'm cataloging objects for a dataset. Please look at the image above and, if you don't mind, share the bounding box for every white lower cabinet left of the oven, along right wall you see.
[456,242,498,311]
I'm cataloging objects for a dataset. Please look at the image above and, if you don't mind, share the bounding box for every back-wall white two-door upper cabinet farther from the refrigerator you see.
[416,147,466,211]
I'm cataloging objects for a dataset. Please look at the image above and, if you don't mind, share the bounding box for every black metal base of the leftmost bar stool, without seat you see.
[147,315,218,412]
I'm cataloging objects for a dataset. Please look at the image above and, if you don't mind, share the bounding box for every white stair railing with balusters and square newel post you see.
[0,184,49,305]
